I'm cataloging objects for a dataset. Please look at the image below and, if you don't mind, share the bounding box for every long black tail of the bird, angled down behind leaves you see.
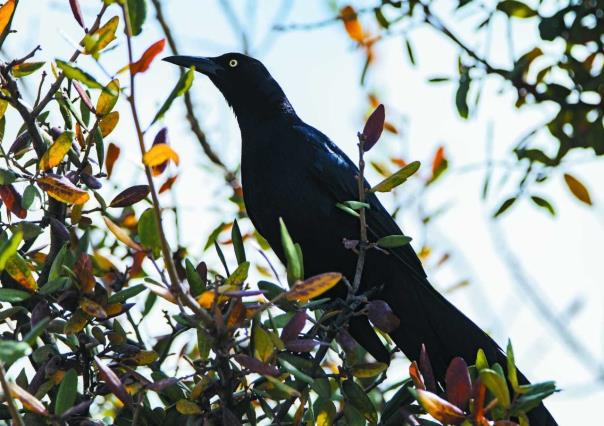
[381,278,557,426]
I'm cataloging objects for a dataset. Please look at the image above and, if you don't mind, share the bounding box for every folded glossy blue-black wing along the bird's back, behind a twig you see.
[296,125,426,279]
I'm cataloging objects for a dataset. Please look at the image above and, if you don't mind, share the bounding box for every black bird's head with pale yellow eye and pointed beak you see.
[164,53,293,120]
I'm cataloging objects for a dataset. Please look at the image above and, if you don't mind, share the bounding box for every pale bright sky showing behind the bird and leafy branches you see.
[5,0,604,424]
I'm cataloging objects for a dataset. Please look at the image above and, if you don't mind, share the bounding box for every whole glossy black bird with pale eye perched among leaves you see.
[164,53,556,426]
